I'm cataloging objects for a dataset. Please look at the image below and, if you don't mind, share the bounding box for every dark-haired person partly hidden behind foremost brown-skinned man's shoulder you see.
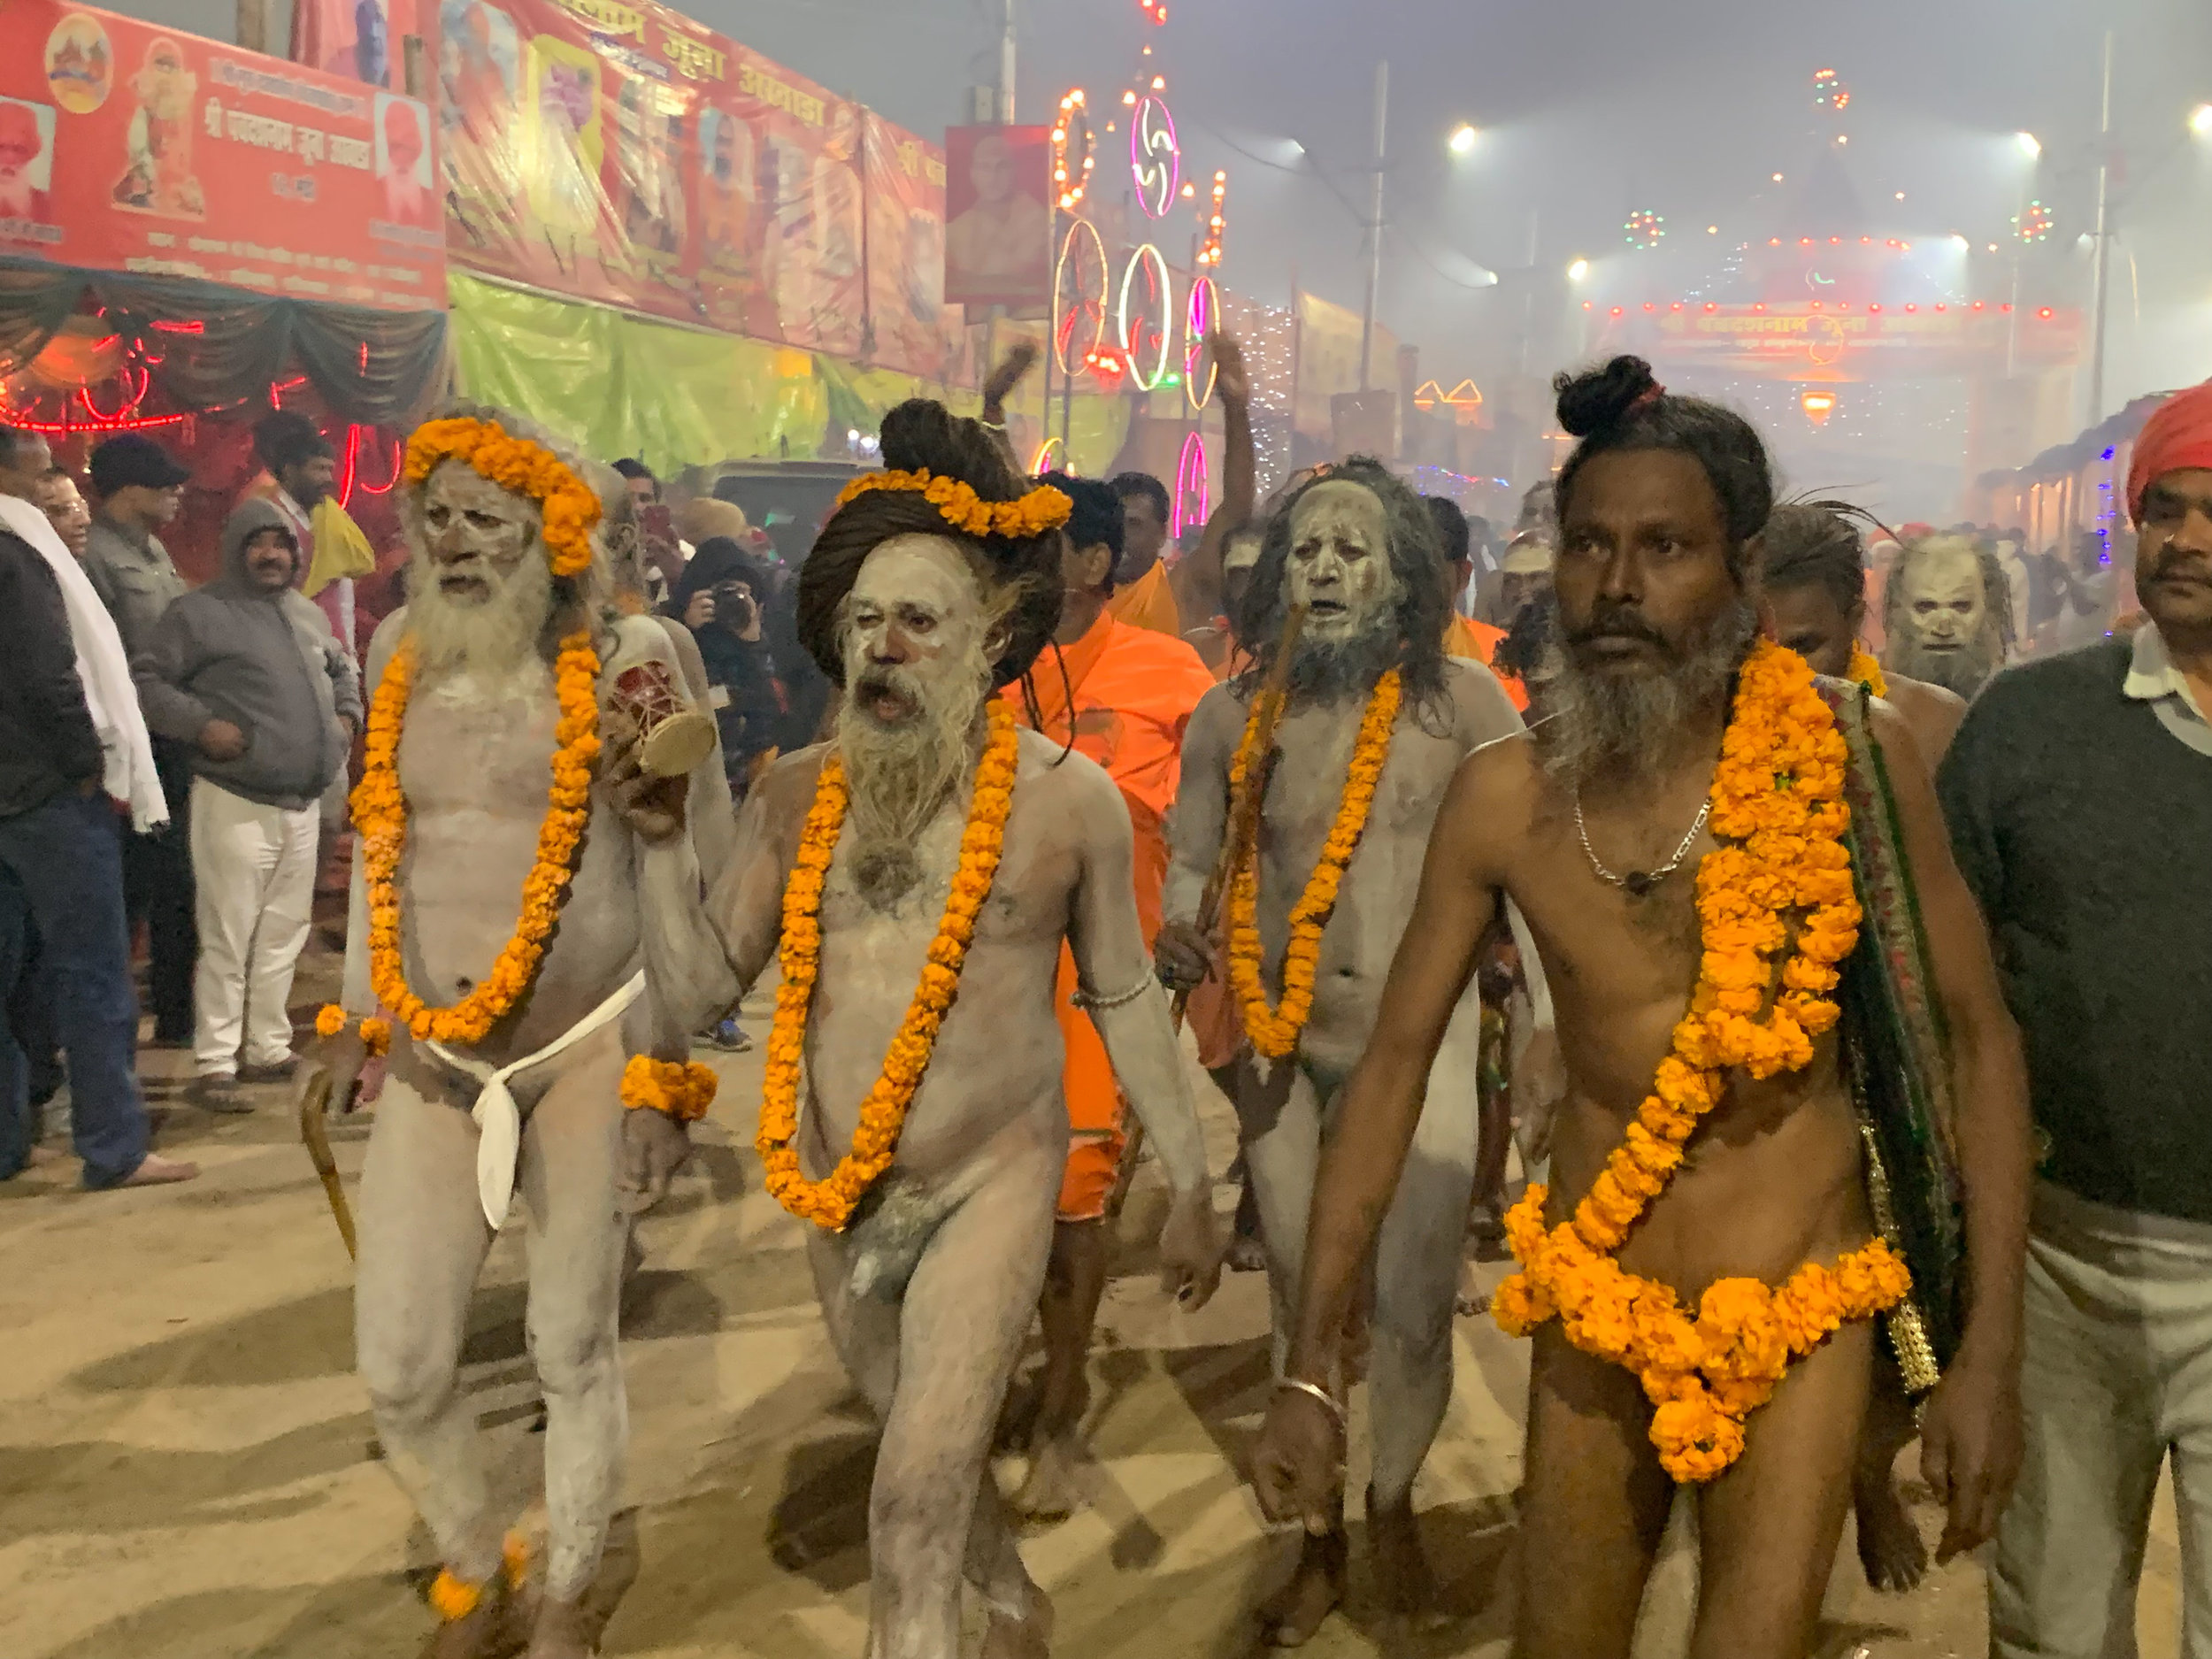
[1759,503,1967,765]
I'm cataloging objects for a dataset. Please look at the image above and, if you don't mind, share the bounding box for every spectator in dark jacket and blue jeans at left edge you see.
[0,518,199,1188]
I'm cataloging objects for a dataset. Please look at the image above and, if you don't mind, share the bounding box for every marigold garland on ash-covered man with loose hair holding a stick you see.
[1228,668,1401,1060]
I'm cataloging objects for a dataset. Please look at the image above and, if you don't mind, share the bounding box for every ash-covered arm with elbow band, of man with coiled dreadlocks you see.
[1062,755,1208,1193]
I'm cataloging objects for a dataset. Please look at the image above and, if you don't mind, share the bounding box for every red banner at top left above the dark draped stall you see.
[0,0,445,310]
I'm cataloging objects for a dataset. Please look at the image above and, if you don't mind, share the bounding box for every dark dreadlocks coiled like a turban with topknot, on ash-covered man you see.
[799,398,1062,686]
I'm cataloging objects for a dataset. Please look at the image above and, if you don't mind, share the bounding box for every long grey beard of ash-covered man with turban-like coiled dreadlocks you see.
[836,644,991,910]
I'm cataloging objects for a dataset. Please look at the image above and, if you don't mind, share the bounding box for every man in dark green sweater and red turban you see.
[1940,383,2212,1659]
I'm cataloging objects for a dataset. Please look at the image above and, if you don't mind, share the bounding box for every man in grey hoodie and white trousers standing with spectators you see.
[133,500,361,1110]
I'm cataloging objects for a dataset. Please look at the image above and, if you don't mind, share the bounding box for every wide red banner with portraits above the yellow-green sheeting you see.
[441,0,867,357]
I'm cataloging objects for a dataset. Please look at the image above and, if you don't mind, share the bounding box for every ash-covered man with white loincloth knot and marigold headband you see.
[303,403,721,1659]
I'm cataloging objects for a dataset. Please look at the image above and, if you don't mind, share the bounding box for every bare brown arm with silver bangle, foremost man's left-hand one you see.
[1252,746,1526,1531]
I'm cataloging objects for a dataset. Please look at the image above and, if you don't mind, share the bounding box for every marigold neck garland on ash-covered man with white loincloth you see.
[317,631,600,1047]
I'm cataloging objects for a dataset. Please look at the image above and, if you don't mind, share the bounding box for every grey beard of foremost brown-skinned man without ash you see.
[1533,602,1759,790]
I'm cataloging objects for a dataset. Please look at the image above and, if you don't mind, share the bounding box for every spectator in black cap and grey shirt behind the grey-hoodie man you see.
[84,432,199,1048]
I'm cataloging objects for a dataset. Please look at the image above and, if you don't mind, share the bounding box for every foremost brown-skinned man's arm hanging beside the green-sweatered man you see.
[1874,706,2035,1560]
